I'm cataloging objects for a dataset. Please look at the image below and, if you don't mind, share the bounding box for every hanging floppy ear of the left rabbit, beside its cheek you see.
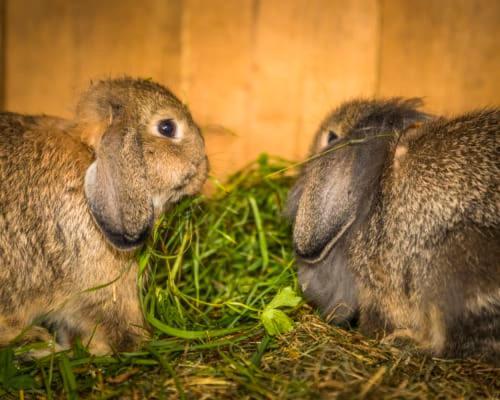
[85,115,153,249]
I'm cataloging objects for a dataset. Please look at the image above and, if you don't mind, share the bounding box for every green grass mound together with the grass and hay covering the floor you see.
[0,156,500,399]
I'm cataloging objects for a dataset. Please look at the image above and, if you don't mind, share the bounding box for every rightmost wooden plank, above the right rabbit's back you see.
[378,0,500,113]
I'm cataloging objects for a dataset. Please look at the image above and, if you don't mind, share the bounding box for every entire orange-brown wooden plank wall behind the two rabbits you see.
[0,0,500,175]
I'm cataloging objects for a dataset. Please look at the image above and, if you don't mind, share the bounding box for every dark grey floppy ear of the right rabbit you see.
[293,138,389,264]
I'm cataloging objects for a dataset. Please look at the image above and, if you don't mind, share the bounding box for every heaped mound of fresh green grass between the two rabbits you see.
[139,156,297,339]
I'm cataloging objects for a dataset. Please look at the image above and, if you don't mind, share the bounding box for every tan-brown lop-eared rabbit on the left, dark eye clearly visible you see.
[0,78,208,354]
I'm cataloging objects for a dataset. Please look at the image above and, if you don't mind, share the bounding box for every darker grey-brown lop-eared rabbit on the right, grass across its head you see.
[288,99,500,364]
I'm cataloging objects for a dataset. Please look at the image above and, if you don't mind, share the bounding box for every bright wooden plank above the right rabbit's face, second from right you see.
[245,0,378,162]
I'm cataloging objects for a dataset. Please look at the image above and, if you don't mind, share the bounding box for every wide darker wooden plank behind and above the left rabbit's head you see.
[6,0,180,116]
